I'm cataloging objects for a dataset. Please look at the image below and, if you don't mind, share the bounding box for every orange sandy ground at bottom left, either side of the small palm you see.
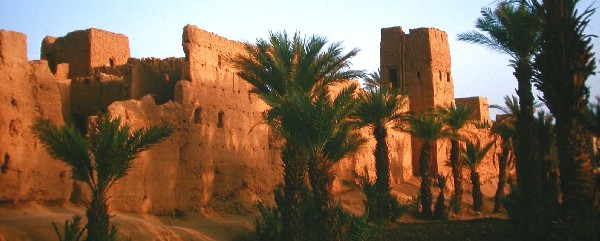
[0,203,254,241]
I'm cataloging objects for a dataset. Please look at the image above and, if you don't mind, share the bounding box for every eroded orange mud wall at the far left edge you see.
[0,30,72,203]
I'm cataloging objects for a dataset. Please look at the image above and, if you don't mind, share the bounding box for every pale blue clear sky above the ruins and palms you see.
[0,0,600,116]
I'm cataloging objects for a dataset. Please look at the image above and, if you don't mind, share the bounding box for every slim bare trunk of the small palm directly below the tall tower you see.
[419,142,433,218]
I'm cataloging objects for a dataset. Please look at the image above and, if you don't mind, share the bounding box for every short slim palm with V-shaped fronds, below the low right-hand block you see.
[461,140,494,211]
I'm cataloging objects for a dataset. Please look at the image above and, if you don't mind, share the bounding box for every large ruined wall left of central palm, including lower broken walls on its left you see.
[98,26,281,213]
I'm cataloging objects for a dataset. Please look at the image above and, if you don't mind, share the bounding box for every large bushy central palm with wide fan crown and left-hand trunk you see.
[232,32,363,240]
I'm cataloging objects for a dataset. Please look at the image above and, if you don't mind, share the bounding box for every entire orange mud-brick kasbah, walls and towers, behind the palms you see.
[0,25,496,214]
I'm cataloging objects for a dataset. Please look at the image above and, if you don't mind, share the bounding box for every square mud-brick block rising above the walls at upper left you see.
[40,28,129,78]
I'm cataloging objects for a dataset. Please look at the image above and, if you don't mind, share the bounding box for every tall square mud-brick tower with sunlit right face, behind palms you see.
[380,27,454,174]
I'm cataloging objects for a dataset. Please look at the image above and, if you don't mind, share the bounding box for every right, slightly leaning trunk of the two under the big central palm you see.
[308,153,342,241]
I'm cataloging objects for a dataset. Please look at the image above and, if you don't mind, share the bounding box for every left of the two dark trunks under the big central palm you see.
[281,145,307,241]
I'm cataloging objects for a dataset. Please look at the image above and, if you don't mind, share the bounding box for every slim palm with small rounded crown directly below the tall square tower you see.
[401,112,454,218]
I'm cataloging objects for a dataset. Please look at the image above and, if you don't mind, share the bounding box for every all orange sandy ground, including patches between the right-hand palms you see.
[0,179,506,241]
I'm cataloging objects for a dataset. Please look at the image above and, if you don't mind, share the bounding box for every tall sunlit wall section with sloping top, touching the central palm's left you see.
[175,25,282,213]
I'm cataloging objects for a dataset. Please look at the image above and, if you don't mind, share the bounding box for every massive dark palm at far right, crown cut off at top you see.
[532,0,596,220]
